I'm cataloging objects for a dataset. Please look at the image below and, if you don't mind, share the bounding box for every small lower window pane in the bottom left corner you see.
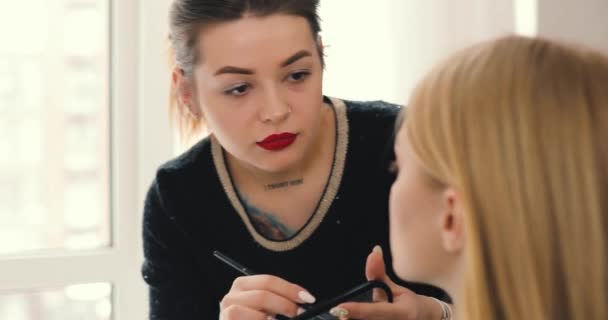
[0,283,112,320]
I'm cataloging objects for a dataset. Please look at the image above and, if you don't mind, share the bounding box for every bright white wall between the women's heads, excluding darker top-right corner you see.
[320,0,515,104]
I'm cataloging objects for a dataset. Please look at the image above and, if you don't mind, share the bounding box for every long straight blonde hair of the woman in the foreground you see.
[404,36,608,320]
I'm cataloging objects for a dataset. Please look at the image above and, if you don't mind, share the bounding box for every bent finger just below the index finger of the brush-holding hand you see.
[220,290,299,317]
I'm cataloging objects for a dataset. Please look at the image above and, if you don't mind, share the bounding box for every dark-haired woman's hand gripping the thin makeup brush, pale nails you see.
[220,275,315,320]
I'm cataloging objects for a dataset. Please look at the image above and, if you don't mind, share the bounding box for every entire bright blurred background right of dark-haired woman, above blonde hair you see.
[320,0,608,104]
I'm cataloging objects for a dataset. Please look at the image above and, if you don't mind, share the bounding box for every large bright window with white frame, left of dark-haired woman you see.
[0,0,151,320]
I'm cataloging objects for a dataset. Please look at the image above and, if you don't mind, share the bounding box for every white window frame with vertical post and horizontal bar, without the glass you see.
[0,0,173,320]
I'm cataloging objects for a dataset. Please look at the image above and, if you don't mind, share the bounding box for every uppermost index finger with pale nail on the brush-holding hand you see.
[230,275,316,303]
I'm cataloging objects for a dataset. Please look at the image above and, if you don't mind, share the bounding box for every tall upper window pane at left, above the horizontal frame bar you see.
[0,0,110,255]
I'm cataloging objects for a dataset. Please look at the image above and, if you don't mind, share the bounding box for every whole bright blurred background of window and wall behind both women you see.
[0,0,608,320]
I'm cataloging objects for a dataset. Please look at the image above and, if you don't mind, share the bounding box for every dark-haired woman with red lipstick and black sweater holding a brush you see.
[143,0,442,320]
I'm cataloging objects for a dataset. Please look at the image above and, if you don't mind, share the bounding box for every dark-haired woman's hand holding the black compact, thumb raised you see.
[332,246,442,320]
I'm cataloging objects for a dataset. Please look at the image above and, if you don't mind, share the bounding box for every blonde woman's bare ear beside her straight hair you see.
[441,187,465,253]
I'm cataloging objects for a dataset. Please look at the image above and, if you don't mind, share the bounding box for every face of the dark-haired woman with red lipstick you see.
[194,14,328,172]
